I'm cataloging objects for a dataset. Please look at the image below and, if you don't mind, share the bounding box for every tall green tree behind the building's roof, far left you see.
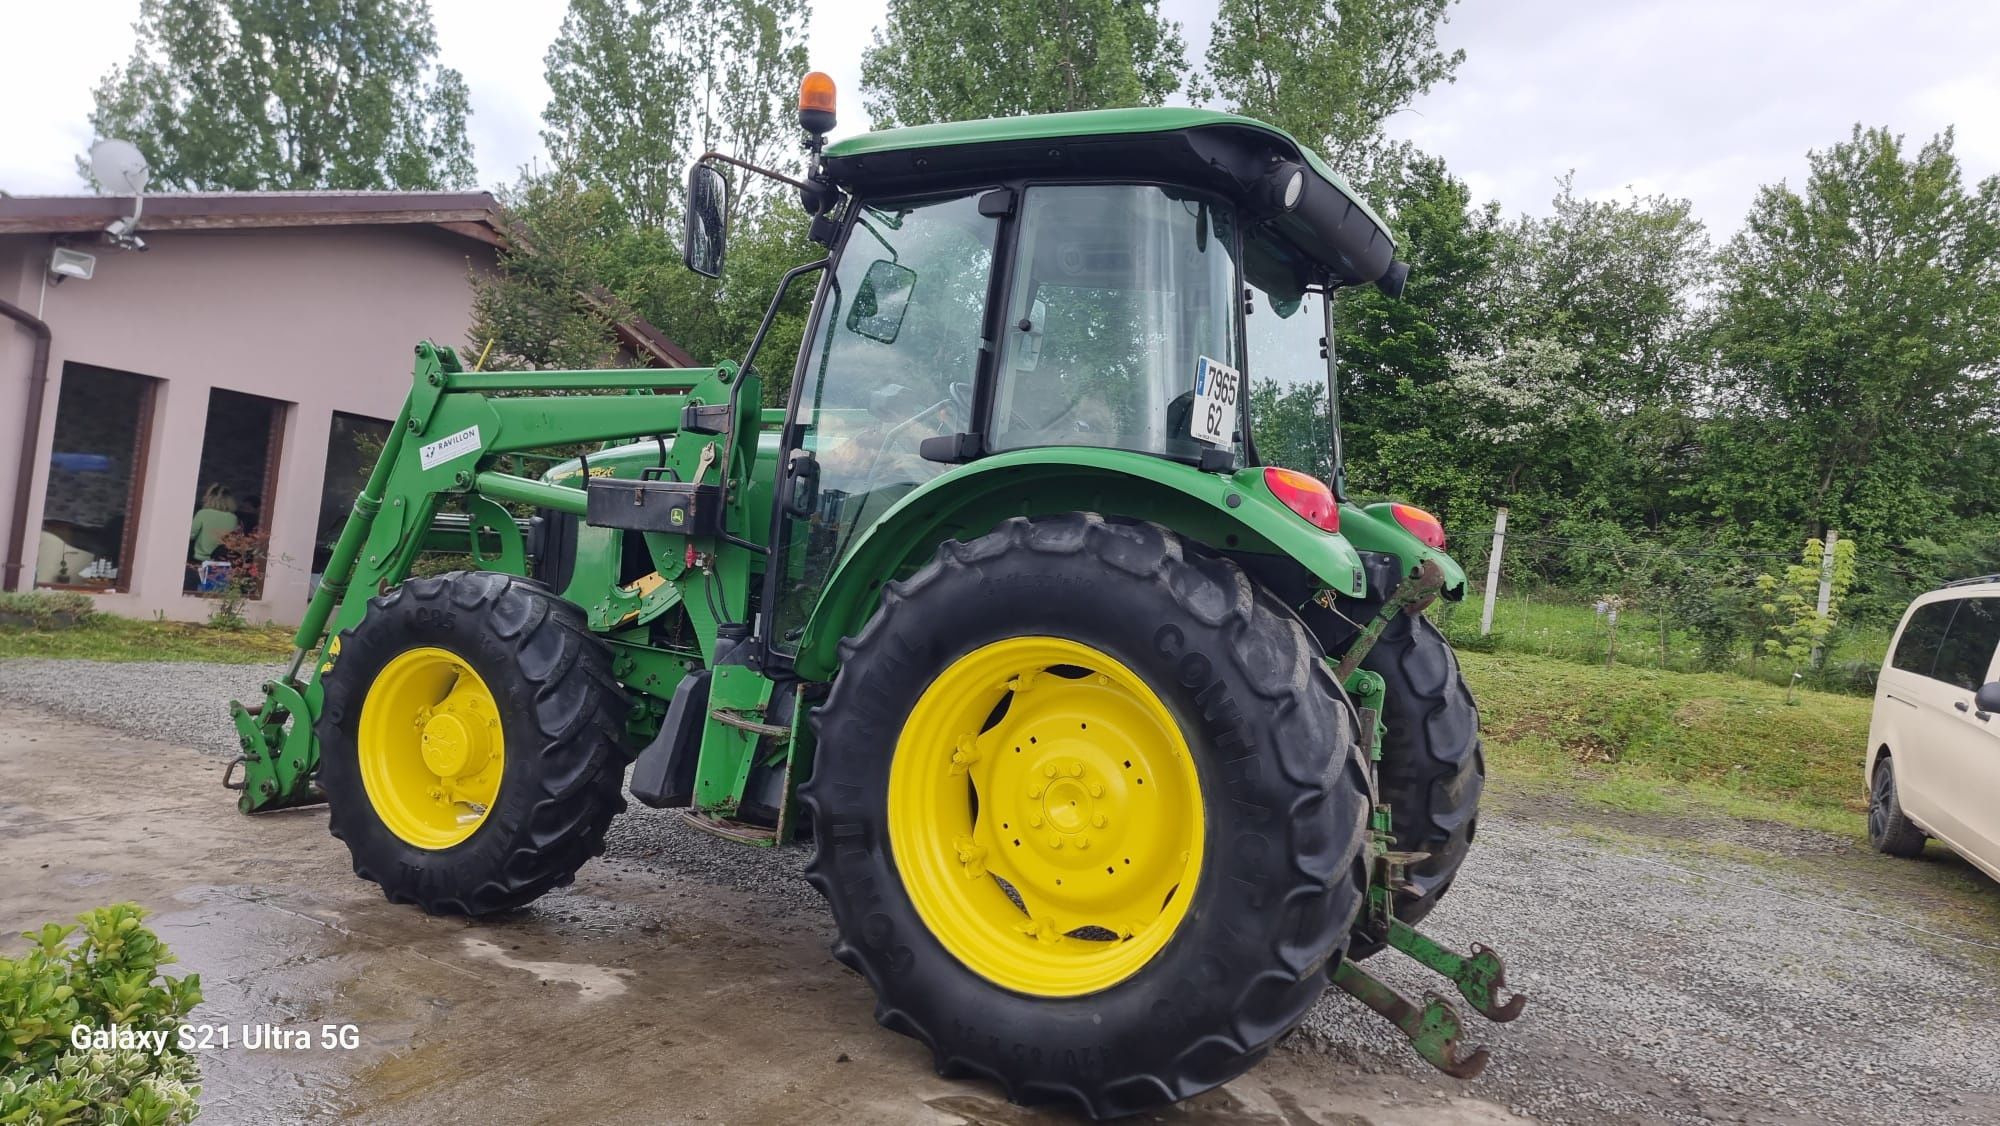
[90,0,474,190]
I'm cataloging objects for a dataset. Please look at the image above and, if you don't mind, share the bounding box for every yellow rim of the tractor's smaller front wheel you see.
[360,646,506,848]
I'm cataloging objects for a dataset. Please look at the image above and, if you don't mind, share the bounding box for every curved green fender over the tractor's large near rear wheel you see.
[796,446,1376,680]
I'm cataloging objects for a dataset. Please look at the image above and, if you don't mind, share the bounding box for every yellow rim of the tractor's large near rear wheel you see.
[888,636,1202,996]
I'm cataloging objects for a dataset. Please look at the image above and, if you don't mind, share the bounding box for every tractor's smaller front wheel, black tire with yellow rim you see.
[314,572,626,916]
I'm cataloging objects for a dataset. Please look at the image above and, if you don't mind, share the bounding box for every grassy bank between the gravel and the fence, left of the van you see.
[1460,652,1872,836]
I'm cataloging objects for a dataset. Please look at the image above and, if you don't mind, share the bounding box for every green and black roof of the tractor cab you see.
[824,106,1396,284]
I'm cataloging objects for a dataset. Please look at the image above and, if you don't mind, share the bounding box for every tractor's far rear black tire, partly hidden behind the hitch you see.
[1348,614,1486,960]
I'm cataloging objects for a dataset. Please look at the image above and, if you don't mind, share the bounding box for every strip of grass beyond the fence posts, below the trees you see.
[1432,592,1896,696]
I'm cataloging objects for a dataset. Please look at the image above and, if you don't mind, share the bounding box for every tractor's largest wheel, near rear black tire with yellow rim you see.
[800,514,1370,1116]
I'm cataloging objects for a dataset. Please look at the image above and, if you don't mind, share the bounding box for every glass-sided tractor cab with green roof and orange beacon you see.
[686,88,1404,664]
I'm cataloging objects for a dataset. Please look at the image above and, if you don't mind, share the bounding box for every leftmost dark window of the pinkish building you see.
[34,364,158,590]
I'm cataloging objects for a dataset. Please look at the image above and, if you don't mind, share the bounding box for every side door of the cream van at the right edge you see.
[1928,596,2000,870]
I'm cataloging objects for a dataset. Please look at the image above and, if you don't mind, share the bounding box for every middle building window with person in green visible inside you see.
[184,388,286,598]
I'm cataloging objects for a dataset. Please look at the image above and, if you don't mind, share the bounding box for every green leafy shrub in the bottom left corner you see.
[0,904,202,1126]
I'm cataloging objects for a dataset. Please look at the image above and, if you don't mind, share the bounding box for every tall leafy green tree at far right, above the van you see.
[1706,126,2000,556]
